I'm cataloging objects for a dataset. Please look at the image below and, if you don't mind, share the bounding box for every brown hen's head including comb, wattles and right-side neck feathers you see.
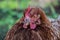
[23,8,50,29]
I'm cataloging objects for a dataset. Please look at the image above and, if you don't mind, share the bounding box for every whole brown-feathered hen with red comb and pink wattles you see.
[5,8,60,40]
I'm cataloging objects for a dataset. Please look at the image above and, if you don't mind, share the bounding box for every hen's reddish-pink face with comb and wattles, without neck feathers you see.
[23,8,41,29]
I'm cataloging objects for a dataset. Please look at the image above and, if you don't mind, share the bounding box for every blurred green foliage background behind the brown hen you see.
[0,0,60,40]
